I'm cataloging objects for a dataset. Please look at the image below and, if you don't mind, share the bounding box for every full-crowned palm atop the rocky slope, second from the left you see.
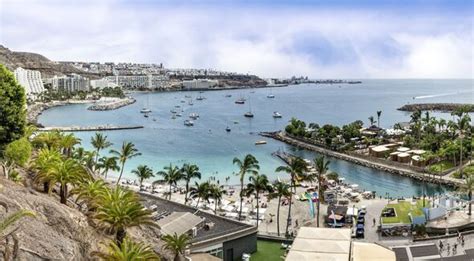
[39,156,90,204]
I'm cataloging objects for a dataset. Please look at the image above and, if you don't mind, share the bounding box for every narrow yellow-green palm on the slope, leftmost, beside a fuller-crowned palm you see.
[33,148,61,192]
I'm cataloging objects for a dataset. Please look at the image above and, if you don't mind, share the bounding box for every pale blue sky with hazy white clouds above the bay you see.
[0,0,474,78]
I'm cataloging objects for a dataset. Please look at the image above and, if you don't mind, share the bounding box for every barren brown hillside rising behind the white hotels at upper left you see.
[0,45,97,78]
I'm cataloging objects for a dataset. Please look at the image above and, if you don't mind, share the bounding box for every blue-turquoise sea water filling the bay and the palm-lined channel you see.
[39,80,474,196]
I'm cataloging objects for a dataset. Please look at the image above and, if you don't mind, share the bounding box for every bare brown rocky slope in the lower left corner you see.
[0,179,106,260]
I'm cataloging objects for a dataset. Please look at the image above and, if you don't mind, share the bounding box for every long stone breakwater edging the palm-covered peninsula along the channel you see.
[260,132,463,187]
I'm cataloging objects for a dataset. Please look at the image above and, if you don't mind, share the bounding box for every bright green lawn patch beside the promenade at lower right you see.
[382,199,429,224]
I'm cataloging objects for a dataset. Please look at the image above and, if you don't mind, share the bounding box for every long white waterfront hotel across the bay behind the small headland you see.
[104,74,169,89]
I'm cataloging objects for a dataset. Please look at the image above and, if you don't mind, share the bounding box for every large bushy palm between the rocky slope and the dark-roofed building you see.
[93,186,157,246]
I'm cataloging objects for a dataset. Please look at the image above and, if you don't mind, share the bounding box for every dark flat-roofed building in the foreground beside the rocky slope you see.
[141,193,257,261]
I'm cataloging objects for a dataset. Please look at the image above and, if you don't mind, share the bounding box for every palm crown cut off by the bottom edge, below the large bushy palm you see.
[92,237,160,261]
